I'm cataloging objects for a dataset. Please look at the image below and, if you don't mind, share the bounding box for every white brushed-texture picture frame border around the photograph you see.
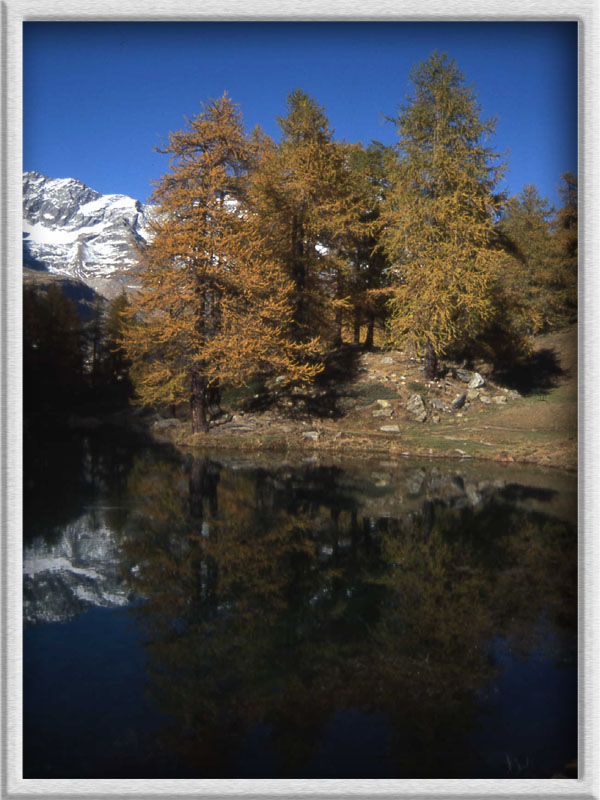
[0,0,600,800]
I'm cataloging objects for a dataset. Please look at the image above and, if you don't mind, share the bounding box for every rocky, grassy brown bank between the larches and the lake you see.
[162,326,577,470]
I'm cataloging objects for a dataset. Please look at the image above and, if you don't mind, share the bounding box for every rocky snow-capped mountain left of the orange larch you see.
[23,172,153,296]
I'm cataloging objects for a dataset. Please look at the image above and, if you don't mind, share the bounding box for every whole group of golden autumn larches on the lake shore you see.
[122,53,577,431]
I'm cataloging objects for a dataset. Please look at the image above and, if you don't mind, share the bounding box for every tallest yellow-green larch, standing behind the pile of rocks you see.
[384,53,503,378]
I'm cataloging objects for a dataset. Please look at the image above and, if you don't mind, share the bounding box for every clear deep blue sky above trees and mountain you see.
[23,22,577,209]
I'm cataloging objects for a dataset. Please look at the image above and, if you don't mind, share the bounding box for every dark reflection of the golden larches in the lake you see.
[118,459,576,777]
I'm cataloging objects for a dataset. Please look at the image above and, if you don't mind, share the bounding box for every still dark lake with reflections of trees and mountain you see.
[23,436,577,778]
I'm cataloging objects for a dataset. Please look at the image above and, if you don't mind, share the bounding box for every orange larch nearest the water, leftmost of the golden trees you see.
[123,95,314,432]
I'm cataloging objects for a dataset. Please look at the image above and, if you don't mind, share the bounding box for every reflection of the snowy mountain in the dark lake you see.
[23,511,130,623]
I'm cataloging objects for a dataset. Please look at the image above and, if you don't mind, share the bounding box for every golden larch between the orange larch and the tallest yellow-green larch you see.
[251,89,367,342]
